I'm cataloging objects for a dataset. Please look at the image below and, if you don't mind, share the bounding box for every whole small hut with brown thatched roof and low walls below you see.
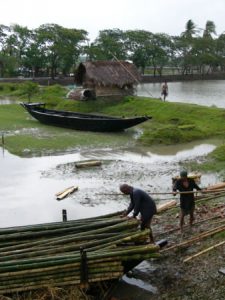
[75,61,141,97]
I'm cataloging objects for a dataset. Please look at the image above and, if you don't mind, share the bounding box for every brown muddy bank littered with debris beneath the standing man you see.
[110,196,225,300]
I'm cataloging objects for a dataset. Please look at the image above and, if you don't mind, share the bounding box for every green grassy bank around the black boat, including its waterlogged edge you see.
[0,84,225,160]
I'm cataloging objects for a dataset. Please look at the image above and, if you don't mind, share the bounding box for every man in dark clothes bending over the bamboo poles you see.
[120,184,157,243]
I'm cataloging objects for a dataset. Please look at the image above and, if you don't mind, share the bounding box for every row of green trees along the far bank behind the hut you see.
[0,20,225,78]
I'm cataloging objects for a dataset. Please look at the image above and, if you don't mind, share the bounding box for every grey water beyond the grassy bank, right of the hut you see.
[137,80,225,108]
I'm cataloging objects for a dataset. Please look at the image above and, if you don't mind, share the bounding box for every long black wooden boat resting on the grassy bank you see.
[21,103,151,132]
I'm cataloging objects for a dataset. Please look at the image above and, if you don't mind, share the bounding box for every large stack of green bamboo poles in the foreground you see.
[0,213,159,294]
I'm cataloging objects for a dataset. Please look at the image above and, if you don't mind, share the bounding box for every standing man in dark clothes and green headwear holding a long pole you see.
[173,171,201,232]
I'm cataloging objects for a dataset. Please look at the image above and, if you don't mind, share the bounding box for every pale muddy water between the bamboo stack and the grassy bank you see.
[0,140,221,227]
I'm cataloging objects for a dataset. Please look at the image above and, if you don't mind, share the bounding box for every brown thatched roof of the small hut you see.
[75,61,141,88]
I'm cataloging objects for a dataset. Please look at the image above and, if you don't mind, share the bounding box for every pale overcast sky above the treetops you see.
[0,0,225,40]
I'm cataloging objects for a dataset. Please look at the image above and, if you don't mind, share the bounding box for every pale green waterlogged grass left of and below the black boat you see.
[0,104,136,156]
